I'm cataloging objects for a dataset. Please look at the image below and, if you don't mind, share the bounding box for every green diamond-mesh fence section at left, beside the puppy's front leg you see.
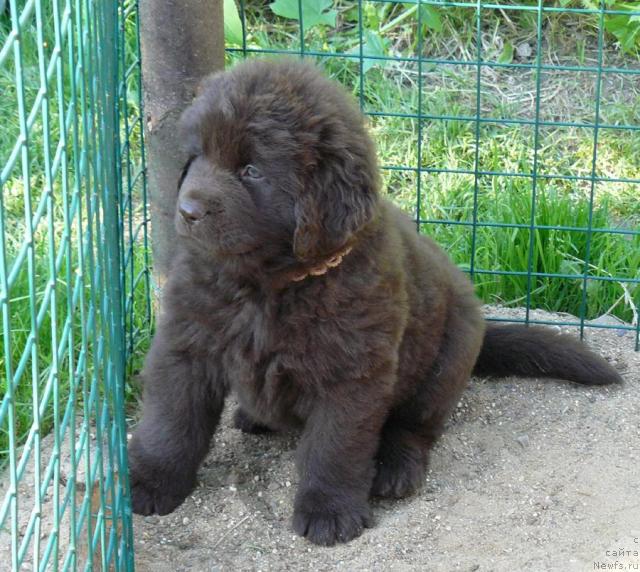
[0,0,150,570]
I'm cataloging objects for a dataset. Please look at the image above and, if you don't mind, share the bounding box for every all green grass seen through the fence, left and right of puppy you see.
[0,0,640,470]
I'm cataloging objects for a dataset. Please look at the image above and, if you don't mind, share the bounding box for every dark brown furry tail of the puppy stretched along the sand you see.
[474,324,622,385]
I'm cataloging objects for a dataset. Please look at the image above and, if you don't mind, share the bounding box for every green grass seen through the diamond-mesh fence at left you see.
[0,3,152,467]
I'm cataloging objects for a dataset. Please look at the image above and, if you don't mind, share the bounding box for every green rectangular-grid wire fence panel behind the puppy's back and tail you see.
[225,0,640,349]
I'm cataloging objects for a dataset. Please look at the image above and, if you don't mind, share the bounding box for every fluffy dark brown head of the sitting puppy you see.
[176,60,379,272]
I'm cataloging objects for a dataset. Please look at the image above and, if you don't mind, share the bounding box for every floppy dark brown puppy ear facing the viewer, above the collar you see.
[293,149,378,261]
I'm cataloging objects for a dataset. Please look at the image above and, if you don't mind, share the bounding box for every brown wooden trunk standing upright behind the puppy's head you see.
[140,0,224,288]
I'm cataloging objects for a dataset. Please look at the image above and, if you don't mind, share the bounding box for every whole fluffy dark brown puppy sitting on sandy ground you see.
[129,60,620,544]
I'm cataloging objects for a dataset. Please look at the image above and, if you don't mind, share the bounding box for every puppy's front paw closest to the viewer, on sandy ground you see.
[293,491,372,546]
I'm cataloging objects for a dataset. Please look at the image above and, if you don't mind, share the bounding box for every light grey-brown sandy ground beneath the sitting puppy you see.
[135,310,640,572]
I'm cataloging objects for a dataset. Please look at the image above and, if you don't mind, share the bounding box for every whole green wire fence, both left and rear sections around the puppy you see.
[0,0,640,570]
